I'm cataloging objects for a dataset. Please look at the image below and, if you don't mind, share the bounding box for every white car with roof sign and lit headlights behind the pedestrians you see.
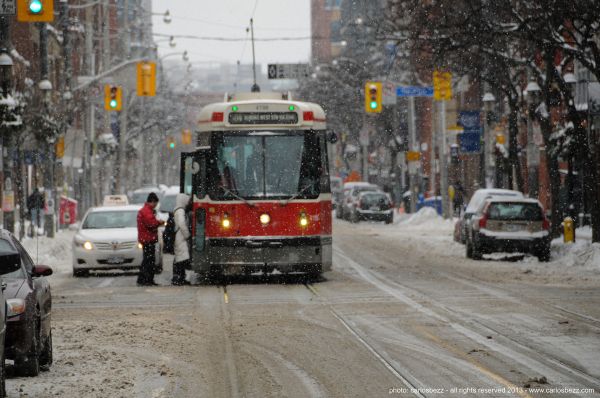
[73,205,162,276]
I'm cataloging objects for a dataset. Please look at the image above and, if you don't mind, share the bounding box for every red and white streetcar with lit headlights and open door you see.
[181,93,332,277]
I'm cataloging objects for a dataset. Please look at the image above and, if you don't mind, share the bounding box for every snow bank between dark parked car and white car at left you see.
[21,230,76,273]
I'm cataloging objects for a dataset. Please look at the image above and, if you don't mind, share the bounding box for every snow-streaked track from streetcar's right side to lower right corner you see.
[334,248,600,388]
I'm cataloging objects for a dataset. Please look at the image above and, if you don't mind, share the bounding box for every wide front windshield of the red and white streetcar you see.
[209,131,323,200]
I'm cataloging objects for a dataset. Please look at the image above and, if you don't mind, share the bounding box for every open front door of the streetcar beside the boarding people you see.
[179,148,208,271]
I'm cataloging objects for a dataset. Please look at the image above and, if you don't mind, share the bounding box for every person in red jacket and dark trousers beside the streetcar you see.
[137,192,164,286]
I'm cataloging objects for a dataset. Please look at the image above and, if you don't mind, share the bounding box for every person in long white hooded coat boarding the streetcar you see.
[171,193,191,286]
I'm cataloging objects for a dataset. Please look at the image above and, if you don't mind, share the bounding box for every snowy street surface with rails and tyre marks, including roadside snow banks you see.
[7,215,600,397]
